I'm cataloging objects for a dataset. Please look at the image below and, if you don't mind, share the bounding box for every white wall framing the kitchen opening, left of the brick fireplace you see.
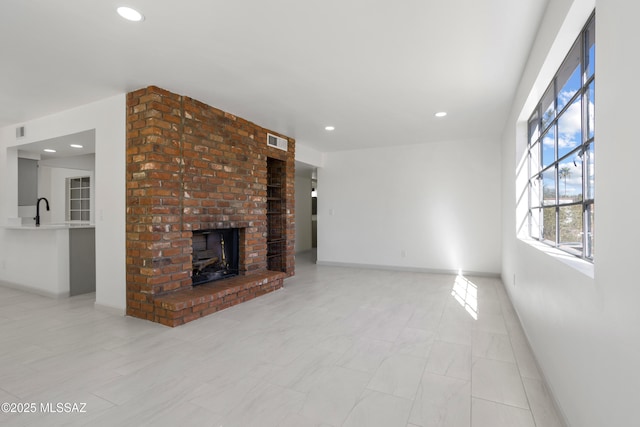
[0,94,126,311]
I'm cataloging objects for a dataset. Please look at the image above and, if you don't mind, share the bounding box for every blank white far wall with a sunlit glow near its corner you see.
[318,140,501,274]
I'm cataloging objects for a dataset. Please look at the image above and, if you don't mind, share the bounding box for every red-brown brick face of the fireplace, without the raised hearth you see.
[126,86,295,320]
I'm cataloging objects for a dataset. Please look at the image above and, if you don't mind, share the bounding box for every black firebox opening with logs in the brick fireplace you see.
[191,228,240,286]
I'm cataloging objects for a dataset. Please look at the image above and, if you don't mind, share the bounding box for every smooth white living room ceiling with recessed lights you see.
[0,0,548,151]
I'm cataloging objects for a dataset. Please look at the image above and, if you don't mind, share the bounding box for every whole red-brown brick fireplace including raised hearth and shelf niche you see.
[126,86,295,326]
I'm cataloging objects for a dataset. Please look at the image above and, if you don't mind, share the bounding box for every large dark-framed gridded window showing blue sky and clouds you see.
[527,13,595,261]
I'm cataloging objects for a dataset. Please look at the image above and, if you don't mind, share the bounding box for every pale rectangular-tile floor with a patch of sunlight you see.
[0,253,562,427]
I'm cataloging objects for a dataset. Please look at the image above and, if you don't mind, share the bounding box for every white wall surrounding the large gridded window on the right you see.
[502,0,640,427]
